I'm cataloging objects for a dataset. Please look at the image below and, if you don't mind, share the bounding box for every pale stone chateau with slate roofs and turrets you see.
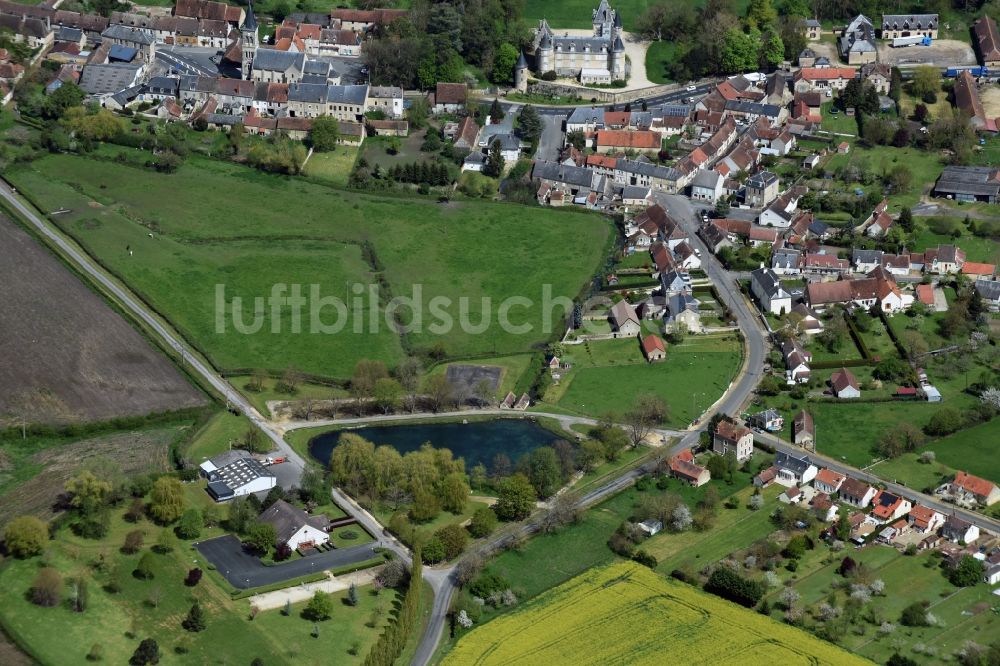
[532,0,628,83]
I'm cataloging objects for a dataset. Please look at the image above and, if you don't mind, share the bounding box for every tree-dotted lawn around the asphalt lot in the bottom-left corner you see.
[0,508,395,665]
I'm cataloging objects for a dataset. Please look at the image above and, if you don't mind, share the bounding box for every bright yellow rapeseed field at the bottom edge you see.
[442,563,871,666]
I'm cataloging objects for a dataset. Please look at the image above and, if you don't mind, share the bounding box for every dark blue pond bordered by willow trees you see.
[309,419,559,470]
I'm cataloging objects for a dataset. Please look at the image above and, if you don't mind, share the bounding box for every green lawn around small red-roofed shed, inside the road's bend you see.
[545,335,742,426]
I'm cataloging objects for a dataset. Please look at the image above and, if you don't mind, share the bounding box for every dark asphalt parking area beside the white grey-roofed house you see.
[195,534,378,590]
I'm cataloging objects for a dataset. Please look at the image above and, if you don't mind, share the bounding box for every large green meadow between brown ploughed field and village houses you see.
[5,155,610,377]
